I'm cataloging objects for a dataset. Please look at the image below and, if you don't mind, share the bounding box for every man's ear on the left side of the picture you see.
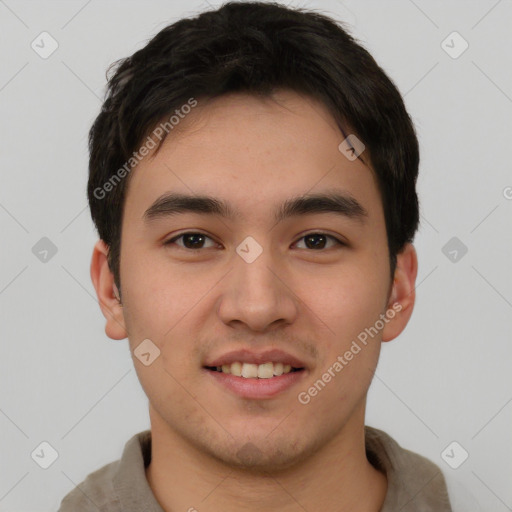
[91,240,127,340]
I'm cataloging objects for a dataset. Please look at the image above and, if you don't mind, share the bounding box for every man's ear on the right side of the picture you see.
[382,243,418,341]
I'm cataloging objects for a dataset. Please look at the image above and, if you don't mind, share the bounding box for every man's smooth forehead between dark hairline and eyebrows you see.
[125,91,379,226]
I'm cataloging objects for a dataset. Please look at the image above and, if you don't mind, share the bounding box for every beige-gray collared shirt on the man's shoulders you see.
[58,426,452,512]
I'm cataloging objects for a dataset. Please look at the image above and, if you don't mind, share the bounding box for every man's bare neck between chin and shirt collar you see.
[146,408,387,512]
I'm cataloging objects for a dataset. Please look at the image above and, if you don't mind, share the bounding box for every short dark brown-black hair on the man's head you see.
[87,2,419,296]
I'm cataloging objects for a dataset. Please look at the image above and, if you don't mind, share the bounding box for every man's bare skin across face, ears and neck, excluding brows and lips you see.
[91,91,417,512]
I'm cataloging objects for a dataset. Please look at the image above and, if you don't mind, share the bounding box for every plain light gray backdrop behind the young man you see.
[0,0,512,512]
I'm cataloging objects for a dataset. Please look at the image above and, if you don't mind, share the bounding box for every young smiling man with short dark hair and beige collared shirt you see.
[60,3,451,512]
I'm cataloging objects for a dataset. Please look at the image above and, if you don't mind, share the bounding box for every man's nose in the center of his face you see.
[217,243,299,332]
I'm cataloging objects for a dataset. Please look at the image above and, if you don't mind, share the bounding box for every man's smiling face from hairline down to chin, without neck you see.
[93,91,415,468]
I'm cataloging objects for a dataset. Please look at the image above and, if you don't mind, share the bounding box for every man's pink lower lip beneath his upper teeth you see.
[204,369,306,399]
